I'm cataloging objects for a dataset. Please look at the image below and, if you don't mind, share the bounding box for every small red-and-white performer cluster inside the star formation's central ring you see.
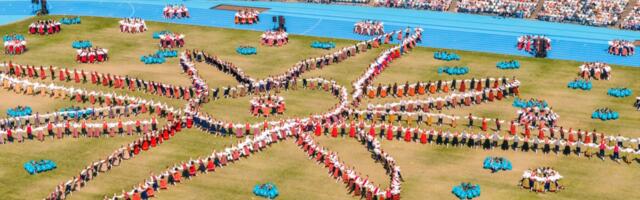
[249,94,286,117]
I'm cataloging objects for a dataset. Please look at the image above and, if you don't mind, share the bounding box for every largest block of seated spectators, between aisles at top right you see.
[538,0,628,26]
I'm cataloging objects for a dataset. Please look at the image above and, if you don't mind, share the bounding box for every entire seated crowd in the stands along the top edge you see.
[301,0,640,30]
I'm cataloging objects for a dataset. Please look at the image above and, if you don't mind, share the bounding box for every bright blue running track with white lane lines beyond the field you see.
[0,0,640,67]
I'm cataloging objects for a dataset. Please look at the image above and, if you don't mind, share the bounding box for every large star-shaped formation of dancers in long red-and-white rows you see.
[0,23,636,199]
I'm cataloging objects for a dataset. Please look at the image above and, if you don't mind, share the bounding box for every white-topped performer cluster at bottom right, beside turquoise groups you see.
[520,167,564,192]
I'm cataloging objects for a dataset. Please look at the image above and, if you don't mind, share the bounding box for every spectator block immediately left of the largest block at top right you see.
[458,0,538,18]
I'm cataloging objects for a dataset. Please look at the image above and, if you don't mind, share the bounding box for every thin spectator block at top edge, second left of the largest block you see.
[375,0,451,11]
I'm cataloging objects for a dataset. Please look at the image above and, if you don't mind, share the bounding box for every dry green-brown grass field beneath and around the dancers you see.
[0,16,640,199]
